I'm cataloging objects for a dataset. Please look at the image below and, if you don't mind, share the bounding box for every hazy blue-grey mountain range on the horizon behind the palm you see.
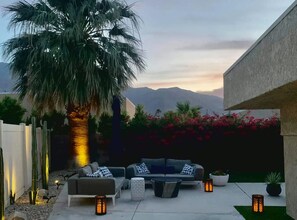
[0,62,223,115]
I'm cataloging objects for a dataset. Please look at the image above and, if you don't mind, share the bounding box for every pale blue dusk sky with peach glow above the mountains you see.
[0,0,294,91]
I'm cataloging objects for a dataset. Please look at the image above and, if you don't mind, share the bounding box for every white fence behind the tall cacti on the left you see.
[0,120,42,207]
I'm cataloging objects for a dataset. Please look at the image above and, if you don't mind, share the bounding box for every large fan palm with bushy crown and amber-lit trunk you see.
[4,0,145,166]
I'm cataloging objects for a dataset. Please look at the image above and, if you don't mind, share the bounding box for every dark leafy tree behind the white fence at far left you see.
[0,96,26,124]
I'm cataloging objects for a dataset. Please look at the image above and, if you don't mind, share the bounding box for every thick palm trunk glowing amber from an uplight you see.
[66,105,90,167]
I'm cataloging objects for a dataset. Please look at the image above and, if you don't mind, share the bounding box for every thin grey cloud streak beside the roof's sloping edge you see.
[178,40,254,51]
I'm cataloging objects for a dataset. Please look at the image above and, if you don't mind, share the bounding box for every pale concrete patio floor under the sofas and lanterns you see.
[49,183,286,220]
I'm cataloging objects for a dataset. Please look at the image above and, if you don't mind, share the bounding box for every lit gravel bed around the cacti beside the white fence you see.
[5,170,73,220]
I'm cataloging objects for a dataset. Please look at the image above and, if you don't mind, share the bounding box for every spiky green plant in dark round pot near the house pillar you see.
[265,172,282,196]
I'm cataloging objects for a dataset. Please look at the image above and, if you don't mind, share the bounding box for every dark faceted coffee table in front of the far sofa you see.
[151,177,182,198]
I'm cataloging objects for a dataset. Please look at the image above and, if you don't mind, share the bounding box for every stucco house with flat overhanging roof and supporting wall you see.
[224,1,297,219]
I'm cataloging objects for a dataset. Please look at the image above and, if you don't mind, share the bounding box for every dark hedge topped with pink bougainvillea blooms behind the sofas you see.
[99,114,283,170]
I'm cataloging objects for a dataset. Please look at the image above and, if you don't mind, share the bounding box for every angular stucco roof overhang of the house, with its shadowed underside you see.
[224,2,297,109]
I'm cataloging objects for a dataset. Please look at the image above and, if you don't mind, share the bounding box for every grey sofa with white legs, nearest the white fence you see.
[68,162,126,206]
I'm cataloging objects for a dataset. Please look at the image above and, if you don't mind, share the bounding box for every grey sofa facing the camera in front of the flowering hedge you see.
[126,158,204,185]
